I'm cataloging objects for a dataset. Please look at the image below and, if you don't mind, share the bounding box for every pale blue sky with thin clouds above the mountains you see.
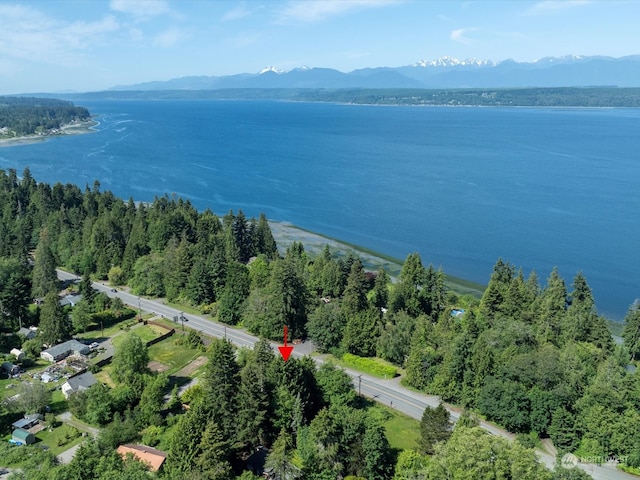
[0,0,640,94]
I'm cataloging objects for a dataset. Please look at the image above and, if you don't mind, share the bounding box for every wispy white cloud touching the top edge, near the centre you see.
[278,0,399,22]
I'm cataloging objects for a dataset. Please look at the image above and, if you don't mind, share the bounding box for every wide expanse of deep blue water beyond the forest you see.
[0,101,640,319]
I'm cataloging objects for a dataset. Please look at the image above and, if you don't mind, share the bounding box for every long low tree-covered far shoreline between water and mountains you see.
[62,87,640,107]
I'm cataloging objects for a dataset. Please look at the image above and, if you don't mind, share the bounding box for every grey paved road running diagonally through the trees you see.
[58,270,638,480]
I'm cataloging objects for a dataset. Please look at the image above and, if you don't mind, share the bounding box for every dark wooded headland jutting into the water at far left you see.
[0,97,90,138]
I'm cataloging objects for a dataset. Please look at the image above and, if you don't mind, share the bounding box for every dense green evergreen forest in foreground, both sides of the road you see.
[0,169,640,480]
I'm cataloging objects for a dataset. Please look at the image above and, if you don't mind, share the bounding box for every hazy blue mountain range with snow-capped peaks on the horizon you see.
[111,55,640,91]
